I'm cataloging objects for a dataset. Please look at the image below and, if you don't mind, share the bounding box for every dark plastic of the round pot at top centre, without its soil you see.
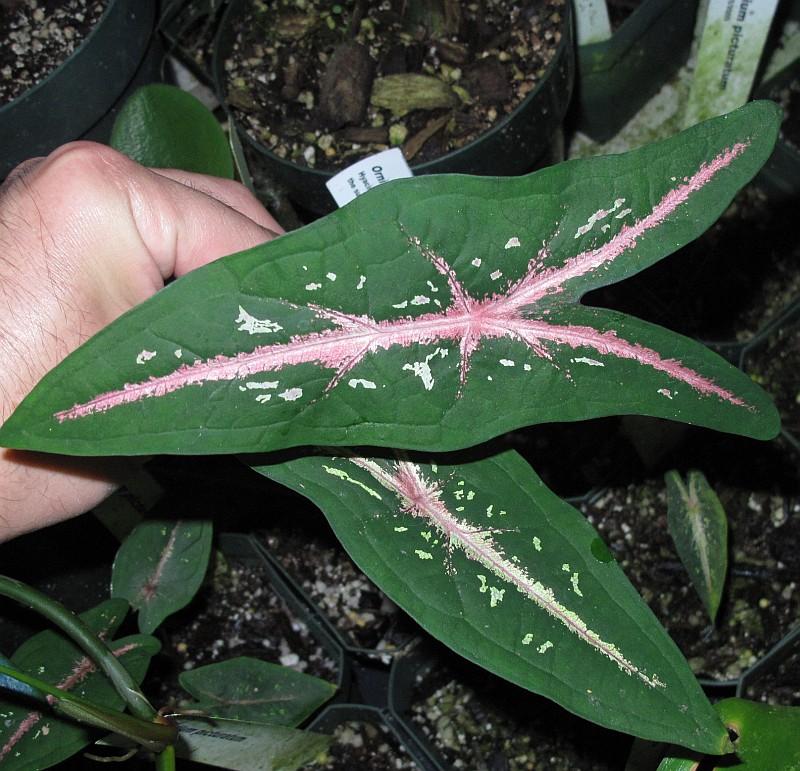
[213,0,575,214]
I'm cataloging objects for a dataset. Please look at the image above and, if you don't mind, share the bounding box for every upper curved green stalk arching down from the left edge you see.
[0,576,156,722]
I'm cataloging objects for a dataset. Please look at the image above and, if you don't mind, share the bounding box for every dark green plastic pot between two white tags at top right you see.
[575,0,698,142]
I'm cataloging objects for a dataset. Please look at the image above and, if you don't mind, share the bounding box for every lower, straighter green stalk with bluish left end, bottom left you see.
[0,664,178,754]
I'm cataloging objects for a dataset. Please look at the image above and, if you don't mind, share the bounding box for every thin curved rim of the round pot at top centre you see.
[211,0,573,181]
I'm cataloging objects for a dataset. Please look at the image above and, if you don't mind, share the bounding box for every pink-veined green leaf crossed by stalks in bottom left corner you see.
[0,599,161,771]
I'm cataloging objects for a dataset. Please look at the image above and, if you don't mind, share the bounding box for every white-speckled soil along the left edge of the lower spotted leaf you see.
[259,530,418,654]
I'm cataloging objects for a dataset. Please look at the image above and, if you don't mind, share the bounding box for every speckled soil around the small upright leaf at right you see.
[582,480,800,681]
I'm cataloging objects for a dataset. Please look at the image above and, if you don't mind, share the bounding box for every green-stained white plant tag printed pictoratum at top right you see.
[684,0,778,127]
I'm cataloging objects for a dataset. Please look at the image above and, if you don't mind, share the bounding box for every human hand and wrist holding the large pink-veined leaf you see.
[0,142,283,541]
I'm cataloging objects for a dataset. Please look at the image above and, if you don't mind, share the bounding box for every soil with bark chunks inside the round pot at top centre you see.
[225,0,564,169]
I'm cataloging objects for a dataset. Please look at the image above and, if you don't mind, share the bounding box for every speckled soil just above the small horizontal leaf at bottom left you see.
[153,559,337,705]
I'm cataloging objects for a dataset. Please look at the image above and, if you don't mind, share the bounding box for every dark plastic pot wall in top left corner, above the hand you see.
[0,0,160,179]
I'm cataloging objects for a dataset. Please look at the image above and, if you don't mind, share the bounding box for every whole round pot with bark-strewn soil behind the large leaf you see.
[213,0,574,213]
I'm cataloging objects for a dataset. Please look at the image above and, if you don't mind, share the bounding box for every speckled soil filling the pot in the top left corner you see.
[0,0,108,105]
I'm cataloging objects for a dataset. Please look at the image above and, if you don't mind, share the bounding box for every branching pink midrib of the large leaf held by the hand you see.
[55,143,747,422]
